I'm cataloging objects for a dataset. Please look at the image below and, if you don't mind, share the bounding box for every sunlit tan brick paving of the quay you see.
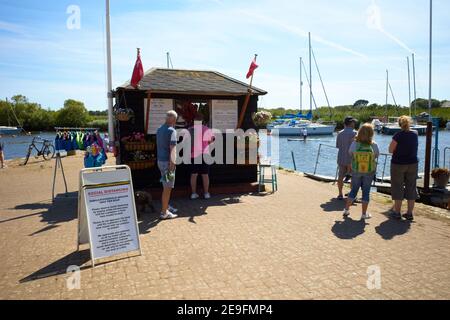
[0,155,450,299]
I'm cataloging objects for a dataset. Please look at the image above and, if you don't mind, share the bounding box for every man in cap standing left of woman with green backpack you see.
[336,117,358,200]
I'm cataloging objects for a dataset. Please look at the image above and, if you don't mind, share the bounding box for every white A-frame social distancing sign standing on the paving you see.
[78,165,141,266]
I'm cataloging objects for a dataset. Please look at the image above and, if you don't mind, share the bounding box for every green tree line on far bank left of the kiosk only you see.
[0,94,108,131]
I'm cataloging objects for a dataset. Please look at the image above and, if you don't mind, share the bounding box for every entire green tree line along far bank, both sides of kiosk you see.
[0,94,450,131]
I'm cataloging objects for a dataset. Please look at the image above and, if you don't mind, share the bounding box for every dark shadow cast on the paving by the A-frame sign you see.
[19,250,90,283]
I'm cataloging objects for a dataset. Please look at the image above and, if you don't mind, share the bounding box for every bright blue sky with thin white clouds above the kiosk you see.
[0,0,450,110]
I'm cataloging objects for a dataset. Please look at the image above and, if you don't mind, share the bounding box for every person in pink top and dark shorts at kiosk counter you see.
[189,113,214,200]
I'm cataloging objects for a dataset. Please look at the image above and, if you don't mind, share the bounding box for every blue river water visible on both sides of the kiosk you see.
[1,131,450,176]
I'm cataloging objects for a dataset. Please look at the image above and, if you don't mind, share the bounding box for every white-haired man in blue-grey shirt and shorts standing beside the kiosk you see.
[156,110,178,220]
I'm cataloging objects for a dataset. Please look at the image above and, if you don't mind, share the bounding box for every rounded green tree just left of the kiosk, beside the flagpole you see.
[55,99,90,127]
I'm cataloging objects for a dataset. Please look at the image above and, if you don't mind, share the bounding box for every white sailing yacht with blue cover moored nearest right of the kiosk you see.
[267,34,336,136]
